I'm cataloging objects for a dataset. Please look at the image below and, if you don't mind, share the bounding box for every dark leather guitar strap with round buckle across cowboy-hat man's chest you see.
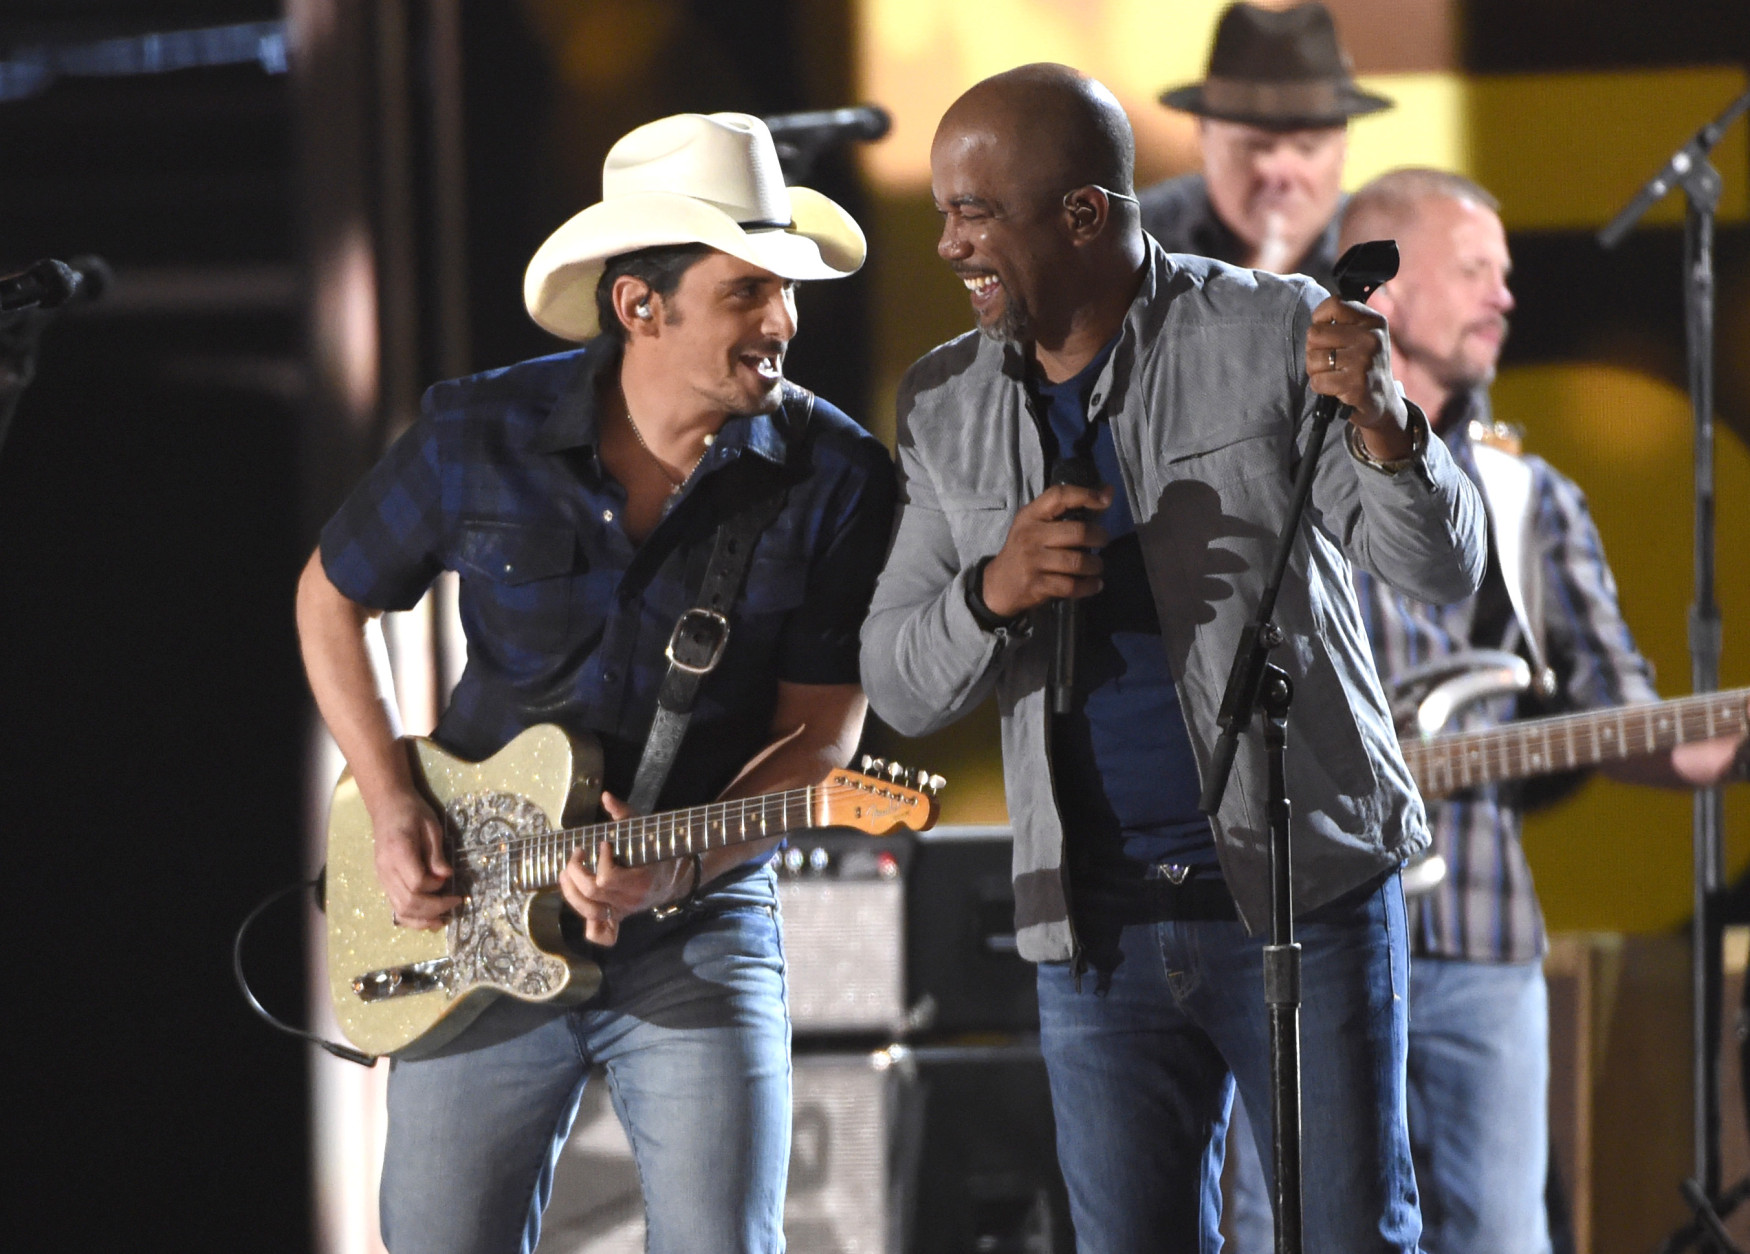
[627,381,814,815]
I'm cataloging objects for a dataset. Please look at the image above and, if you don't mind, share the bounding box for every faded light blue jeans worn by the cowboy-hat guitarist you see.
[382,869,789,1254]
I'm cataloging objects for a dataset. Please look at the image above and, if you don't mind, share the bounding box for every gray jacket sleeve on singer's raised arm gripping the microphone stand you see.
[1292,289,1488,605]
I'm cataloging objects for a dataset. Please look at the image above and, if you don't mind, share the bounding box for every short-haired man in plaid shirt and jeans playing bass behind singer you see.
[1236,168,1743,1254]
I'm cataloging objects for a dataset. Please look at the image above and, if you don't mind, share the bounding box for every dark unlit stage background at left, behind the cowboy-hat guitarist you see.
[0,0,865,1251]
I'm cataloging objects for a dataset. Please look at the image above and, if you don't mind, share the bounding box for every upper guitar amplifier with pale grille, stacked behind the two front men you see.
[779,827,1040,1041]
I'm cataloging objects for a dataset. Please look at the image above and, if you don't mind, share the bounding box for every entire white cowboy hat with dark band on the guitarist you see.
[523,114,868,339]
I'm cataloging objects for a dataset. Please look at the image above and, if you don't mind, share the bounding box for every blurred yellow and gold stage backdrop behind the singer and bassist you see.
[851,0,1750,930]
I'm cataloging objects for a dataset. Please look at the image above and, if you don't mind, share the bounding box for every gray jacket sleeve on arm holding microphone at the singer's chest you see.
[863,400,1008,736]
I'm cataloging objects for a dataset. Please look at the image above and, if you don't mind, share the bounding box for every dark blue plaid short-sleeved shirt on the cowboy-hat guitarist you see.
[322,339,894,808]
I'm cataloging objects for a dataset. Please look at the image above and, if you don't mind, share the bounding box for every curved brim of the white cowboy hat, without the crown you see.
[523,187,868,341]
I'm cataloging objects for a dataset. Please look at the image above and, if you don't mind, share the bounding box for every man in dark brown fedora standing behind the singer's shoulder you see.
[1141,0,1391,290]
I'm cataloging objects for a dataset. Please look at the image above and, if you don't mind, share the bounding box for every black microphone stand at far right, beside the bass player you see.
[1598,91,1750,1254]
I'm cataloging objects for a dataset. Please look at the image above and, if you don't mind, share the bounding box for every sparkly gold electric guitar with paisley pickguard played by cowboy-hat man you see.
[326,724,943,1058]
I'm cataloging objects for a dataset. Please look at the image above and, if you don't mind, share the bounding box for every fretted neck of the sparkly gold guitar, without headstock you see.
[513,785,824,892]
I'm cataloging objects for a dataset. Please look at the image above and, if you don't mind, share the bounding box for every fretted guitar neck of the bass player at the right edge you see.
[1404,689,1750,798]
